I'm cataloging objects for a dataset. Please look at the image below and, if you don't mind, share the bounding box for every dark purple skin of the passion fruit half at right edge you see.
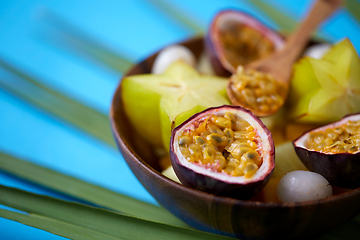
[293,144,360,189]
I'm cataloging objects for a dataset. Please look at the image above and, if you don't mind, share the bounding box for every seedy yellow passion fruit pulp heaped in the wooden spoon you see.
[230,66,286,115]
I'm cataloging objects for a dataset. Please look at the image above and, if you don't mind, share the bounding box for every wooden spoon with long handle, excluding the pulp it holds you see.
[227,0,342,117]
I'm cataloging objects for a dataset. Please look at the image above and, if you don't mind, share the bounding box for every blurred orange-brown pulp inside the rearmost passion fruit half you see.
[219,23,274,69]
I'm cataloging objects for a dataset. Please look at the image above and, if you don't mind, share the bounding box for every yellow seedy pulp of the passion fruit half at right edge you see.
[305,120,360,153]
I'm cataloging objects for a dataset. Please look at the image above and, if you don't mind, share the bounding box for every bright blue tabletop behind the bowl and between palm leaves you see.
[0,0,360,239]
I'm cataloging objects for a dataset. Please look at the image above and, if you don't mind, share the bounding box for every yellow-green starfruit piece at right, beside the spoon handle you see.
[289,39,360,123]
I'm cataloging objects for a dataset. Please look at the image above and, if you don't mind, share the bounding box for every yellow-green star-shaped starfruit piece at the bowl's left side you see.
[122,61,229,149]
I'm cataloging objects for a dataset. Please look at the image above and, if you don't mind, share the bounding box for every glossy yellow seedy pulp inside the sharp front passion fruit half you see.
[178,112,262,178]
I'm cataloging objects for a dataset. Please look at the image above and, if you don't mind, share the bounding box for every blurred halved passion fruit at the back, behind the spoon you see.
[205,10,284,77]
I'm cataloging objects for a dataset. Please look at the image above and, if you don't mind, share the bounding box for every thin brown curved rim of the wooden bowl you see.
[109,36,360,210]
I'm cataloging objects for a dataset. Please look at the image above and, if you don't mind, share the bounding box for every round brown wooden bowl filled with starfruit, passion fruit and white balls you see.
[111,5,360,239]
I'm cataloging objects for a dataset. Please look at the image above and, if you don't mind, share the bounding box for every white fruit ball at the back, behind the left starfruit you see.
[151,45,196,74]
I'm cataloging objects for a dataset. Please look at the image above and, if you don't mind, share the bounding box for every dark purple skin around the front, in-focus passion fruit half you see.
[170,105,275,200]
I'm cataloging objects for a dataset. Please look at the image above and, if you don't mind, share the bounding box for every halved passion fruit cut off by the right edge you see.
[293,114,360,188]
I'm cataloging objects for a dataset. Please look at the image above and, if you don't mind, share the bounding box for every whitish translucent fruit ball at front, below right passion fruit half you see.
[276,171,333,202]
